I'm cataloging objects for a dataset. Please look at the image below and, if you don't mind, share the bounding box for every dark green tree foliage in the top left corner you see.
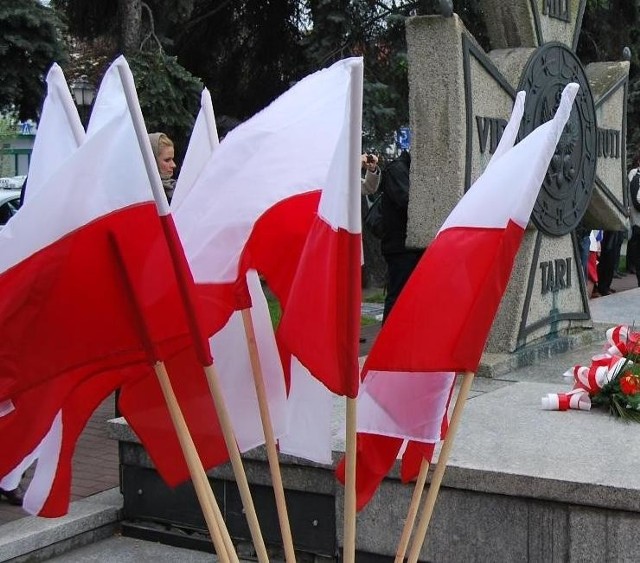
[0,0,65,119]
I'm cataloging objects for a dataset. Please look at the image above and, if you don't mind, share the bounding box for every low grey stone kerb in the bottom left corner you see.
[0,488,122,563]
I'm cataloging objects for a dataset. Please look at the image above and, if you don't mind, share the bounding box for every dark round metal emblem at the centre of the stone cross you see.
[518,42,598,236]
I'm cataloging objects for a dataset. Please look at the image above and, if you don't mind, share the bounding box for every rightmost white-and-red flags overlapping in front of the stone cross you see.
[338,84,578,509]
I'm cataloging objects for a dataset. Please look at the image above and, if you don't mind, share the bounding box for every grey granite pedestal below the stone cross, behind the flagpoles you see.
[110,376,640,563]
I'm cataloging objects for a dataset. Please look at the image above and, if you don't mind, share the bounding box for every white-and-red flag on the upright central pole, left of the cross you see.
[175,59,362,397]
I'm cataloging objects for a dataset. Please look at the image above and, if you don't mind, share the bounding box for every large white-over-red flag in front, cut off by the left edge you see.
[0,76,188,401]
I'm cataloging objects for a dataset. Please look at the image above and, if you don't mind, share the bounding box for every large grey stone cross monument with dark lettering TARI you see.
[407,0,629,353]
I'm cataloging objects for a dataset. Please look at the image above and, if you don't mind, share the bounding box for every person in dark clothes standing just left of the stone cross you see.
[380,151,424,322]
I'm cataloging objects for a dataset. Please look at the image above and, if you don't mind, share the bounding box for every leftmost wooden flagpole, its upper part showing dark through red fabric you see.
[109,233,238,563]
